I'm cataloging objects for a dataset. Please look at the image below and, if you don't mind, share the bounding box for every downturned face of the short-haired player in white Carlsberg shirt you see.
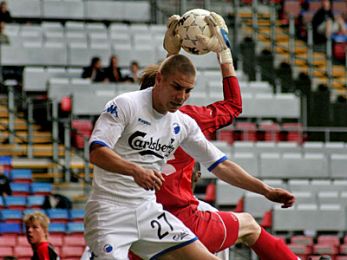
[154,73,195,113]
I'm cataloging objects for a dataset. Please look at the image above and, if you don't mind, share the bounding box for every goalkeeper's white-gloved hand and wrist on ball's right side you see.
[197,12,233,64]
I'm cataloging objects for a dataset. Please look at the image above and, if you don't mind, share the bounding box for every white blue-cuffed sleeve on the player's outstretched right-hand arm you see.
[181,116,227,171]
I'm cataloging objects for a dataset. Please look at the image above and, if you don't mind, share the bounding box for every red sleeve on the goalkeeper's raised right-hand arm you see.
[180,77,242,135]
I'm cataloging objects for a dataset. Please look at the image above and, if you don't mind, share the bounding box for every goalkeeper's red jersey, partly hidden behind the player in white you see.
[156,77,242,212]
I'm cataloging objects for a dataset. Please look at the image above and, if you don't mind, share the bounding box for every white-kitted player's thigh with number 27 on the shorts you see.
[130,202,218,259]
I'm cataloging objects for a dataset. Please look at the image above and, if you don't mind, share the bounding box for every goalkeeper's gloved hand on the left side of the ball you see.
[163,15,182,56]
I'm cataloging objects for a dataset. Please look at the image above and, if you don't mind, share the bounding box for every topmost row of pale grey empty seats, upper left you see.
[8,0,150,22]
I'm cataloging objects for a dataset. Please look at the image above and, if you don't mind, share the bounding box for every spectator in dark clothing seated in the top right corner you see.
[312,0,347,44]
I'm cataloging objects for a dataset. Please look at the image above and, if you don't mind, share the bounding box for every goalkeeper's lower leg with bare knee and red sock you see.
[232,213,298,260]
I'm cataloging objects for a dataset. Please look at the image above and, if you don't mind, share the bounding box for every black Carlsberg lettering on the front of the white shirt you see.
[128,131,175,159]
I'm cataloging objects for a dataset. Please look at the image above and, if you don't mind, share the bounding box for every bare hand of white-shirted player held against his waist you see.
[133,168,164,190]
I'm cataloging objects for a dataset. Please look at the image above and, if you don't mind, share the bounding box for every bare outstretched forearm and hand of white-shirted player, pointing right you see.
[212,160,295,208]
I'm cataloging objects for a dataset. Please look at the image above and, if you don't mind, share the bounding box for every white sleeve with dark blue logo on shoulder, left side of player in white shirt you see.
[89,97,130,148]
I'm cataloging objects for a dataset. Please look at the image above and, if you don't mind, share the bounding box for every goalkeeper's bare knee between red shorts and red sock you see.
[238,213,261,245]
